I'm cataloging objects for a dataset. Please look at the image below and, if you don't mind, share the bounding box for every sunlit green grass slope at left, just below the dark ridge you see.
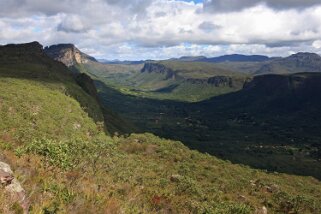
[0,78,105,142]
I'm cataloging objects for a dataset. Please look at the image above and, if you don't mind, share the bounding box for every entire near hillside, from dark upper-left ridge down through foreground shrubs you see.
[0,43,321,213]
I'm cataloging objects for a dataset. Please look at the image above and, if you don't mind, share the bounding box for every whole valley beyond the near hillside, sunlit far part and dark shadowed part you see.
[43,44,321,179]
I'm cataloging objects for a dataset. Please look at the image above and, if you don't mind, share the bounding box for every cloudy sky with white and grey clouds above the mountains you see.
[0,0,321,60]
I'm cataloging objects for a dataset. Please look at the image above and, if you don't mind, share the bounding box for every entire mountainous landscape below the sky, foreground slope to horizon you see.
[0,42,321,214]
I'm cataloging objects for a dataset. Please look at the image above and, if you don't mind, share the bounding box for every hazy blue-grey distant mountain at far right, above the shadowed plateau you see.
[255,52,321,74]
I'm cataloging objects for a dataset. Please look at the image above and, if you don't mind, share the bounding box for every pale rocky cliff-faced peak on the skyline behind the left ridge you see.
[44,44,97,67]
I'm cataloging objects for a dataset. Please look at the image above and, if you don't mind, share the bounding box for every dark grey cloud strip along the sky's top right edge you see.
[204,0,321,12]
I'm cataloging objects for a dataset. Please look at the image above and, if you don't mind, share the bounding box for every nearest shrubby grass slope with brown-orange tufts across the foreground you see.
[1,134,321,213]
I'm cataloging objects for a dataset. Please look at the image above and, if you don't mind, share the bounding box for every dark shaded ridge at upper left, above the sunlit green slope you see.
[0,42,103,125]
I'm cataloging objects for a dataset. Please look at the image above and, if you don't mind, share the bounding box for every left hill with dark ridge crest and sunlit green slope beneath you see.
[0,42,104,142]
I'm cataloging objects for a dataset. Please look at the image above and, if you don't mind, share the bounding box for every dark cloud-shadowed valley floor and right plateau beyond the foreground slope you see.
[97,73,321,178]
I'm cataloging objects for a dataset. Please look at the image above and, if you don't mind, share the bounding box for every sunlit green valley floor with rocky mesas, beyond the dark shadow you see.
[76,61,250,102]
